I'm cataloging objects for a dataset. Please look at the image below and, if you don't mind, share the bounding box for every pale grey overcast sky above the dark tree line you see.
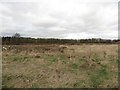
[0,0,118,39]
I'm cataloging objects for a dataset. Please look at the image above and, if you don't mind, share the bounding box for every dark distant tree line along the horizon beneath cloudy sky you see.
[2,33,120,45]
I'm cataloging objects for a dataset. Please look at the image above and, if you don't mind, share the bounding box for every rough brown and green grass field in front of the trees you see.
[2,44,118,88]
